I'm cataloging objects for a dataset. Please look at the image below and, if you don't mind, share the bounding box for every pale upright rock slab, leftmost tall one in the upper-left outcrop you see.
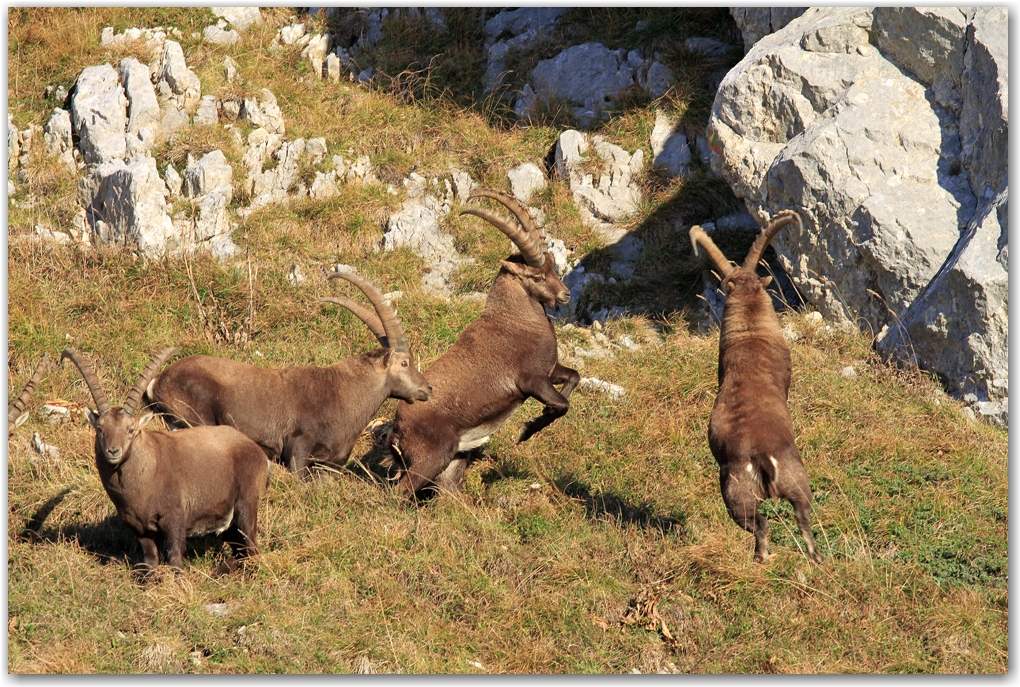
[70,64,128,164]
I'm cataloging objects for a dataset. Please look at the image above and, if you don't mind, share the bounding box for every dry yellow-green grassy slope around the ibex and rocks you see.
[7,8,1008,673]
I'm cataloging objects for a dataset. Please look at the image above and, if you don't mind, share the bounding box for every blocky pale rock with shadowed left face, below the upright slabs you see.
[90,155,180,257]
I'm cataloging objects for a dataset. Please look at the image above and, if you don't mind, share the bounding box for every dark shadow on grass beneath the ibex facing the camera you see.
[17,488,229,582]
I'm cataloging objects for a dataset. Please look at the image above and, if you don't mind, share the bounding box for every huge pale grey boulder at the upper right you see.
[709,7,1008,416]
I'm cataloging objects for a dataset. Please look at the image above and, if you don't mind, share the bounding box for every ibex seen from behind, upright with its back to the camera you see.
[691,210,822,563]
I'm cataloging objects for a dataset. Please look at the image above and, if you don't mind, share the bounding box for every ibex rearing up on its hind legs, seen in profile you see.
[390,189,580,498]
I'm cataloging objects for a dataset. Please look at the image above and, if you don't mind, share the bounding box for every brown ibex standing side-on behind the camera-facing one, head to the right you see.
[147,272,432,478]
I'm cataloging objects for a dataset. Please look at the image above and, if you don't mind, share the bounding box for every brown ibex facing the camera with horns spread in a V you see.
[60,348,269,574]
